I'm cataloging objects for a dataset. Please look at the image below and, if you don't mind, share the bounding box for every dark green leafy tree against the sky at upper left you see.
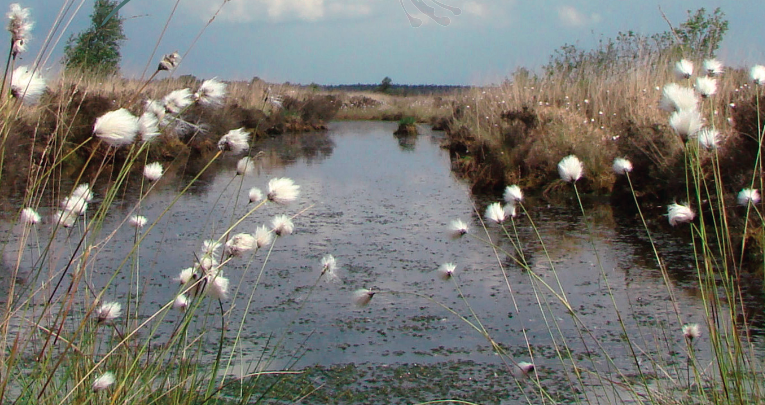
[64,0,126,75]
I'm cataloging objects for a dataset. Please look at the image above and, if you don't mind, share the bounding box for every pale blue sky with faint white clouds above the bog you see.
[7,0,765,85]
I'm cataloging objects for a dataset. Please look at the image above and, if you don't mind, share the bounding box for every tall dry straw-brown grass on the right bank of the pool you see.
[442,53,754,196]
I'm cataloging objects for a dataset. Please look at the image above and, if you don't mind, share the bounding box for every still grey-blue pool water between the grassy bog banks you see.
[1,122,752,403]
